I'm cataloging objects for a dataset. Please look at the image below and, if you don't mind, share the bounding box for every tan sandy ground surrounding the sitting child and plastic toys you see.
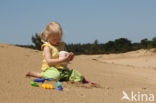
[0,43,156,103]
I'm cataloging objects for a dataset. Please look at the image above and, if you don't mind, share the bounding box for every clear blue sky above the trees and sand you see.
[0,0,156,44]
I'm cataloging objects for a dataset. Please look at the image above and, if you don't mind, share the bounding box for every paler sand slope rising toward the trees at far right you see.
[88,49,156,69]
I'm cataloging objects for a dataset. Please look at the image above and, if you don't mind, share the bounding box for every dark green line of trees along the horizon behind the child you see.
[17,33,156,54]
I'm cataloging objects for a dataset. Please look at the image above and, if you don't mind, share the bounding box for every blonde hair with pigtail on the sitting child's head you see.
[40,22,63,43]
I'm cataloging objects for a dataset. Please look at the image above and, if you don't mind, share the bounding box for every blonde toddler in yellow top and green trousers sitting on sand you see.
[26,22,86,82]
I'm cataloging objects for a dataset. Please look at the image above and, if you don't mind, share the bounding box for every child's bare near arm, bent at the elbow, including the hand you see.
[43,46,71,65]
